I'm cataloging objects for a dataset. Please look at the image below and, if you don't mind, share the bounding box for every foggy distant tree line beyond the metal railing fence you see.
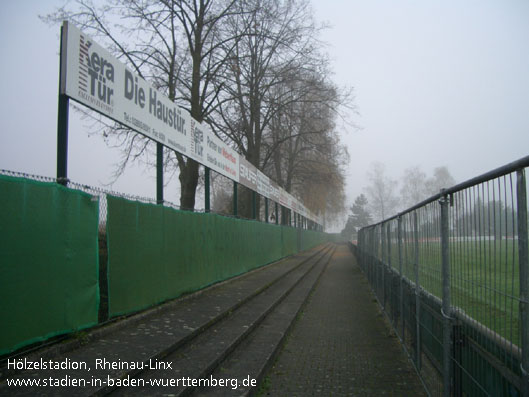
[342,163,518,240]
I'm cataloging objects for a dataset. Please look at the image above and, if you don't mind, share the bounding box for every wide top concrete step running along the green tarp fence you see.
[0,243,328,396]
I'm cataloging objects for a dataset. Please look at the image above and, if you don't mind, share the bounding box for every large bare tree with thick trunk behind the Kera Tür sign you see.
[43,0,235,209]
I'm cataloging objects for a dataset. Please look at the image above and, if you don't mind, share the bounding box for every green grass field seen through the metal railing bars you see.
[379,239,520,345]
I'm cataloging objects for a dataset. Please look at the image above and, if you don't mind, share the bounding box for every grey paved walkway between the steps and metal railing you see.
[260,245,426,397]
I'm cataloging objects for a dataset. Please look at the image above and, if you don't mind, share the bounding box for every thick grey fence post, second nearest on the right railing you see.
[439,196,452,397]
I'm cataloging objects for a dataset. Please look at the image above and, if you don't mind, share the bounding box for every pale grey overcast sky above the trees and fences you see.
[0,0,529,227]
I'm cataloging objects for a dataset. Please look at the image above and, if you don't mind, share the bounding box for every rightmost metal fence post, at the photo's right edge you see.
[516,168,529,397]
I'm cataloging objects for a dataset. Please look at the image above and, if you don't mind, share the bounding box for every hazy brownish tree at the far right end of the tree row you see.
[256,66,352,218]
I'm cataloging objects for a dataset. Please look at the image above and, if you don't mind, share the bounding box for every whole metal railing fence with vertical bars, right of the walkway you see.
[356,156,529,397]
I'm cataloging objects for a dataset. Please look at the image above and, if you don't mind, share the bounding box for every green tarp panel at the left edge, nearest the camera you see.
[0,175,99,355]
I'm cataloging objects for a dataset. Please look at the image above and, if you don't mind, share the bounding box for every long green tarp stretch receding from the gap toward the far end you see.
[107,196,328,317]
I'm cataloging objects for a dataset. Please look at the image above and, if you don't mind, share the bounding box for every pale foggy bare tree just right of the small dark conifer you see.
[365,162,399,221]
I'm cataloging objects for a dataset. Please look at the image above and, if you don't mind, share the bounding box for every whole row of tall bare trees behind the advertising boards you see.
[48,0,348,220]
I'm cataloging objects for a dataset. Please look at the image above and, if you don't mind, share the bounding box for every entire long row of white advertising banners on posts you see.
[59,21,316,221]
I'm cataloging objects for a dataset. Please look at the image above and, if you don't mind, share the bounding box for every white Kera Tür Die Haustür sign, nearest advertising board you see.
[61,23,191,156]
